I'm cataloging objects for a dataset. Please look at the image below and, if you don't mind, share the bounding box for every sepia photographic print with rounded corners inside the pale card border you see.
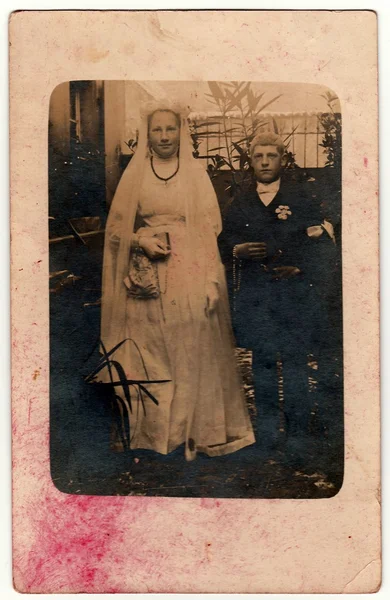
[48,80,344,499]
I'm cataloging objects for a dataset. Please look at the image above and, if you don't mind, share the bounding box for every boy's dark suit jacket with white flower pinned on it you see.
[218,180,333,351]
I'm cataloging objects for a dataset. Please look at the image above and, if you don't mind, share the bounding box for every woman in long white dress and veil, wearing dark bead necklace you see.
[101,106,255,460]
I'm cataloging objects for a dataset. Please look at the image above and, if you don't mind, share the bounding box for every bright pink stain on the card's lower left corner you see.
[14,486,151,593]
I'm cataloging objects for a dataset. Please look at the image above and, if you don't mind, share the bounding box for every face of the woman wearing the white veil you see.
[149,111,180,158]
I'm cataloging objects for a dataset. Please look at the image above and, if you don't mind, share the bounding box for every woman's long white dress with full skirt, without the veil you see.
[110,159,255,458]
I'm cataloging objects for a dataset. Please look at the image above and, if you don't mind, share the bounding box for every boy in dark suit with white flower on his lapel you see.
[219,133,333,456]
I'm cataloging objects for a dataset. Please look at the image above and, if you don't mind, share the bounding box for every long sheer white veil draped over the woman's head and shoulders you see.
[101,104,221,349]
